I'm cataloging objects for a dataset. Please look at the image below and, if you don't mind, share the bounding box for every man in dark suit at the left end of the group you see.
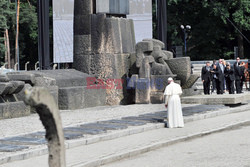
[201,62,211,95]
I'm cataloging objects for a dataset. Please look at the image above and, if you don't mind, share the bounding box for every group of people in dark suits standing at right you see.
[201,57,247,95]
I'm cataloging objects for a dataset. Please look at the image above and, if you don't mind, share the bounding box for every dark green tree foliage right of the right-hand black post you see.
[153,0,250,60]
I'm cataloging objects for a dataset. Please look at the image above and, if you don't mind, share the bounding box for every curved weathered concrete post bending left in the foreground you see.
[25,87,66,167]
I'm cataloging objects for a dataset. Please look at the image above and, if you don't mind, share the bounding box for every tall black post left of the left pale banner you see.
[37,0,50,70]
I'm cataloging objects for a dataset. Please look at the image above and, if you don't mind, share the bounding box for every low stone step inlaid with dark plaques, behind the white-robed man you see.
[0,105,239,164]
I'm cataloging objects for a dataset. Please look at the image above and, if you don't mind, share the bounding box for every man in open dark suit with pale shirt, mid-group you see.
[215,59,225,94]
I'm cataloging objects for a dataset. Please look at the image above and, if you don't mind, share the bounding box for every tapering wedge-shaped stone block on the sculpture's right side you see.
[167,57,191,85]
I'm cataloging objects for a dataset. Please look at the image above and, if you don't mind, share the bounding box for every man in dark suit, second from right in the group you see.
[225,62,235,94]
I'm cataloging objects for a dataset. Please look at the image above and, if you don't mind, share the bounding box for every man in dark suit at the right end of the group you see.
[234,57,242,94]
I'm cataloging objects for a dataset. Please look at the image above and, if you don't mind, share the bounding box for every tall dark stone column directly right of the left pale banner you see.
[73,0,93,73]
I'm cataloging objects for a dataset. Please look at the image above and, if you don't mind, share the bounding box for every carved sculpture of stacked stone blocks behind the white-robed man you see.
[131,39,199,103]
